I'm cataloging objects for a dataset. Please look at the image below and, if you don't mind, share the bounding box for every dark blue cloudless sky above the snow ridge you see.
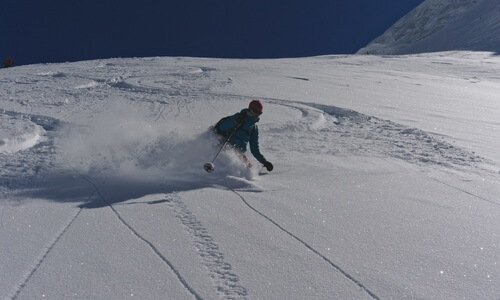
[5,0,423,65]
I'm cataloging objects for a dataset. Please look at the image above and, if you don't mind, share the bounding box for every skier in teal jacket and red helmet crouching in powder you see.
[214,100,274,171]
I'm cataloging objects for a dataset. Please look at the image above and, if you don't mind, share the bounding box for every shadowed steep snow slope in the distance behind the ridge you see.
[358,0,500,54]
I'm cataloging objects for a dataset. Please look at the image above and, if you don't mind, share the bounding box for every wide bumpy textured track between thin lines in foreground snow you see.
[165,194,248,299]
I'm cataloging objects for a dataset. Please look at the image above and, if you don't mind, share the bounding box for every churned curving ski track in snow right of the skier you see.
[261,99,485,173]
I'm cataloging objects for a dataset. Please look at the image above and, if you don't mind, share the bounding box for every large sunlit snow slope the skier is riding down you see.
[0,52,500,299]
